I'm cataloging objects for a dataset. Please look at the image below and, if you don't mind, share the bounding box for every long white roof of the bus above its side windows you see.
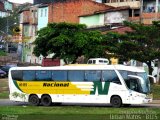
[10,64,145,72]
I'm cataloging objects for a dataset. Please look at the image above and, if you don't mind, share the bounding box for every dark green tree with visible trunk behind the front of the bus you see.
[105,22,160,74]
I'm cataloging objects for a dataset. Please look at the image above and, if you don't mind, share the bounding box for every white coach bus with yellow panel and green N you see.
[9,65,152,107]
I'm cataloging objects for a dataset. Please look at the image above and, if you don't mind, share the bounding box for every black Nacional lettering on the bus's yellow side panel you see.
[43,82,69,87]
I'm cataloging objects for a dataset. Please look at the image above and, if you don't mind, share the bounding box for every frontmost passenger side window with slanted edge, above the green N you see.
[102,70,121,84]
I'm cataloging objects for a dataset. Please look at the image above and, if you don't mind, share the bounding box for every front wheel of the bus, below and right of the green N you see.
[111,96,122,108]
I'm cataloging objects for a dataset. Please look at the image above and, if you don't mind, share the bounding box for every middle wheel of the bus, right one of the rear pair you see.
[41,95,52,106]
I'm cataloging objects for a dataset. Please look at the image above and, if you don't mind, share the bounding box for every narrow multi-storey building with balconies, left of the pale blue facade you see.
[19,5,38,63]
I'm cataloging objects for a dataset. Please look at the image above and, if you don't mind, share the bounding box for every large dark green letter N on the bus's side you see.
[90,81,110,95]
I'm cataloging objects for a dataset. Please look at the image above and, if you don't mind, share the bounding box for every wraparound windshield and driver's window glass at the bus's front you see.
[119,70,150,94]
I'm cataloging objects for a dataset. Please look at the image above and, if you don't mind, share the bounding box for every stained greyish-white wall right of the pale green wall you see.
[104,10,129,24]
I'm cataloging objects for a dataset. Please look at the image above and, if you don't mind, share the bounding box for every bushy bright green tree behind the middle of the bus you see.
[33,23,105,63]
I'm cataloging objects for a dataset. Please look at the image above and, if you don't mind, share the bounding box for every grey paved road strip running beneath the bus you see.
[0,99,160,108]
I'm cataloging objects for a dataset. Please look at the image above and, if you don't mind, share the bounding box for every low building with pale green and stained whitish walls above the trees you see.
[79,7,130,27]
